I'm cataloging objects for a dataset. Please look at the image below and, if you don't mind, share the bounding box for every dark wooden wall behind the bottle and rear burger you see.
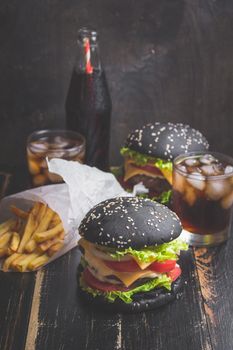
[0,0,233,172]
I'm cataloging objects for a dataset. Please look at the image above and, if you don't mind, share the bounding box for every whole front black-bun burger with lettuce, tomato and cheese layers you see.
[78,197,187,312]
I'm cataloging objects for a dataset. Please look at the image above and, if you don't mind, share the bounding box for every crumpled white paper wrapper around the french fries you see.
[0,159,136,272]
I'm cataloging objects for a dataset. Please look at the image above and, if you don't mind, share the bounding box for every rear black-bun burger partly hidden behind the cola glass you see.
[121,122,209,203]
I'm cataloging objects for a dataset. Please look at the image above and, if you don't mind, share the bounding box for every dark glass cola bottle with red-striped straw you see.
[66,28,112,170]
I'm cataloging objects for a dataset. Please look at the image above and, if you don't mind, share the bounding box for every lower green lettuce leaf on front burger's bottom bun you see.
[80,274,172,304]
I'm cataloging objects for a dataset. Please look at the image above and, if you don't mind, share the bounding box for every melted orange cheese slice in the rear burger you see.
[124,158,172,184]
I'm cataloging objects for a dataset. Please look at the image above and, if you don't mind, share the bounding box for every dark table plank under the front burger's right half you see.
[121,251,212,350]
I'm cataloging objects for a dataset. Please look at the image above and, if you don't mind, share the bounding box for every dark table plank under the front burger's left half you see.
[30,248,119,350]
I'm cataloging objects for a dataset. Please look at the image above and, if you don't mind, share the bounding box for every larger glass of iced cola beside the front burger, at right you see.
[172,152,233,246]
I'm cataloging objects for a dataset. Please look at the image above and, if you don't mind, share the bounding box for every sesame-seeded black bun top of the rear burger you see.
[125,122,209,160]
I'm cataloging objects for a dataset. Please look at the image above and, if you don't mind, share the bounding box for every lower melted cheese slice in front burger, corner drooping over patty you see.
[84,246,159,287]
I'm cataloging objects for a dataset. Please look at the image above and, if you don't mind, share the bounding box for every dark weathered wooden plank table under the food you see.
[0,170,233,350]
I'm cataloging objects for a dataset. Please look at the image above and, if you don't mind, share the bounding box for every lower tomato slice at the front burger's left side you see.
[83,268,129,292]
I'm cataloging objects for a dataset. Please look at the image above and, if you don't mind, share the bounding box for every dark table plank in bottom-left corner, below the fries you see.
[0,272,35,350]
